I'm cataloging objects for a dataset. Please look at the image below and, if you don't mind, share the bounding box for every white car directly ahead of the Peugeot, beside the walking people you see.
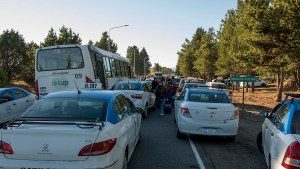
[111,81,156,118]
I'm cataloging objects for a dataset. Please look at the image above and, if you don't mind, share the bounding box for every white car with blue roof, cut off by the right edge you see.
[257,94,300,169]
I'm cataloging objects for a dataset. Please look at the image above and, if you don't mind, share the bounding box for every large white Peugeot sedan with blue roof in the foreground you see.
[0,91,143,169]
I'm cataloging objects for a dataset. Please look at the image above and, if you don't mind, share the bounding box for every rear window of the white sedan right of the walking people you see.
[189,93,230,103]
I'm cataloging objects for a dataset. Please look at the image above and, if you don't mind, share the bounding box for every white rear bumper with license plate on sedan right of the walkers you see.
[177,116,239,136]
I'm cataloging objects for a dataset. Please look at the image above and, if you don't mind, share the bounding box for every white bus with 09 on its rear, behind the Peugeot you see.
[35,45,131,97]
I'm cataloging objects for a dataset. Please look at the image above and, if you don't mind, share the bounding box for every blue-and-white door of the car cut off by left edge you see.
[0,90,17,123]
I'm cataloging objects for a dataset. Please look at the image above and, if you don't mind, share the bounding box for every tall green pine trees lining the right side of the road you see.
[176,0,300,100]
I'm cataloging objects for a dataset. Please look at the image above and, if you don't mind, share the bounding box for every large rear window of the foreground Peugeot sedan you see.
[22,98,107,121]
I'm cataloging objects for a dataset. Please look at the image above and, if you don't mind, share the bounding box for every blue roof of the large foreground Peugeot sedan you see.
[43,90,121,100]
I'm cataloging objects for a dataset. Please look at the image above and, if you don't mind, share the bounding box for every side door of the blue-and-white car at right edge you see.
[264,104,289,159]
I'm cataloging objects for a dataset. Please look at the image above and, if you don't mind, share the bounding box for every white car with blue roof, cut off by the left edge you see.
[0,87,36,123]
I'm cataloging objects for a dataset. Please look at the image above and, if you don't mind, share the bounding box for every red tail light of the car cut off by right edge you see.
[281,142,300,169]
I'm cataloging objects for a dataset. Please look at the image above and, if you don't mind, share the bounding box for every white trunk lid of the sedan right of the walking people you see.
[188,102,236,124]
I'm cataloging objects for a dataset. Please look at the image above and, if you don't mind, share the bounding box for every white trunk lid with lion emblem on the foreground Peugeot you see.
[1,124,100,161]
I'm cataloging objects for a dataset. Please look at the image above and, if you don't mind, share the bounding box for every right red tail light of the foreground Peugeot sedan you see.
[78,138,117,156]
